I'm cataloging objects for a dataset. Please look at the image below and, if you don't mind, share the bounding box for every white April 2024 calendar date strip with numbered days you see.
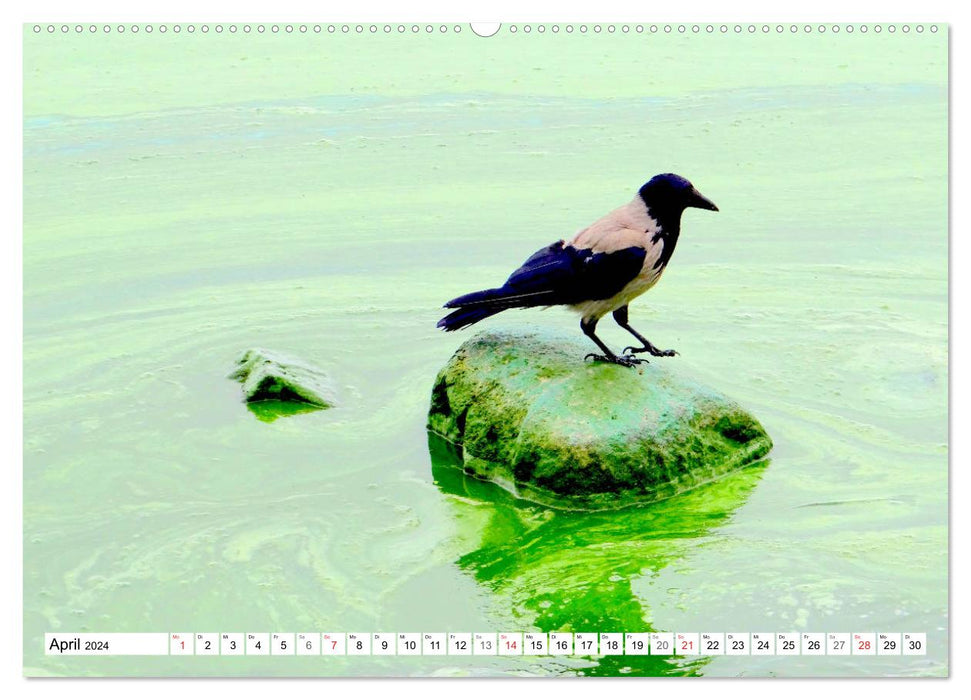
[44,632,927,657]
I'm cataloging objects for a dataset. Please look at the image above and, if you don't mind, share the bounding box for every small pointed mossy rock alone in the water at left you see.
[229,349,337,413]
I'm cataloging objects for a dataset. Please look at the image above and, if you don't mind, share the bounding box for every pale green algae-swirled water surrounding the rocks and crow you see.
[23,25,948,676]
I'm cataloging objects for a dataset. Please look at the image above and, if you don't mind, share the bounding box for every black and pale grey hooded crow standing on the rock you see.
[438,173,718,367]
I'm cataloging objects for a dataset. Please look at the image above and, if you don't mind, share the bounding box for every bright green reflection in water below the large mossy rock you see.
[428,433,767,676]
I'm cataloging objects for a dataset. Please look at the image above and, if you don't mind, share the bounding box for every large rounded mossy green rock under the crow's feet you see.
[428,331,772,509]
